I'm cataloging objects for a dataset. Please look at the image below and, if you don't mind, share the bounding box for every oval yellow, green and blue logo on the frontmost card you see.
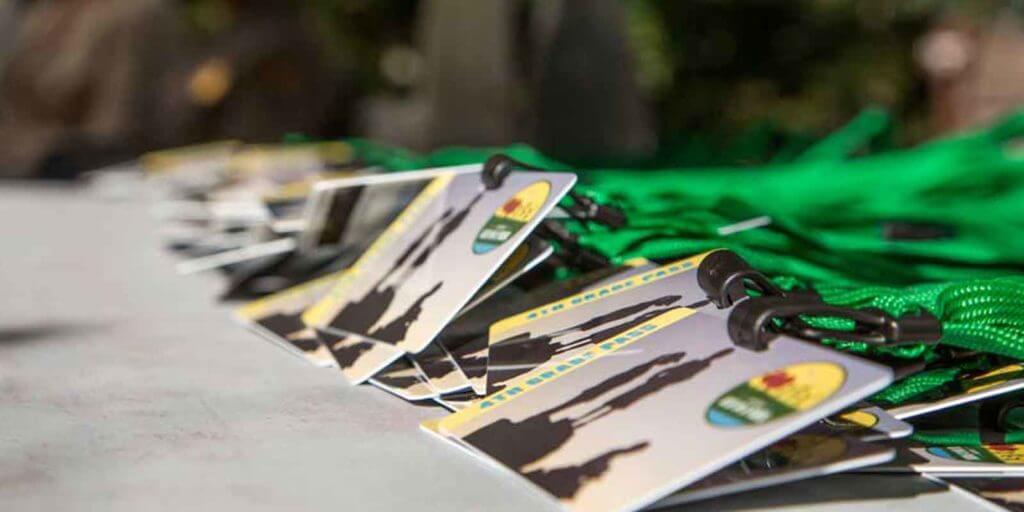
[707,362,846,427]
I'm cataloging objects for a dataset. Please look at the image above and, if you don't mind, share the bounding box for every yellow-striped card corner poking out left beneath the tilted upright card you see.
[236,271,344,367]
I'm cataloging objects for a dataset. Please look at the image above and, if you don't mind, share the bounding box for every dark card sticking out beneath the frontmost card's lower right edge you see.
[651,427,896,509]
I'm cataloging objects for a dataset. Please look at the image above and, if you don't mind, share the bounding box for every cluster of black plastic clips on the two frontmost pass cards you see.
[697,250,942,351]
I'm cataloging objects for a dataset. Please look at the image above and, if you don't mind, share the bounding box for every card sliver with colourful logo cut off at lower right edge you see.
[865,444,1024,476]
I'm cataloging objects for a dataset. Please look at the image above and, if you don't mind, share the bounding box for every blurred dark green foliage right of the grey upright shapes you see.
[626,0,1007,141]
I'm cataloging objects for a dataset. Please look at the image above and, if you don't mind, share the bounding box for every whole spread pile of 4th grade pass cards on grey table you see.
[142,144,1024,511]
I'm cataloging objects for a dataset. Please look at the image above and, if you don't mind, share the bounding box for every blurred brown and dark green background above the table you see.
[0,0,1024,178]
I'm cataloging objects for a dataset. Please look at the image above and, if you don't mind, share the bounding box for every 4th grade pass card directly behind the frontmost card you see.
[486,254,727,394]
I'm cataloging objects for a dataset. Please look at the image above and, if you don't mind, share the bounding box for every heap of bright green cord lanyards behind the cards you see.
[350,111,1024,404]
